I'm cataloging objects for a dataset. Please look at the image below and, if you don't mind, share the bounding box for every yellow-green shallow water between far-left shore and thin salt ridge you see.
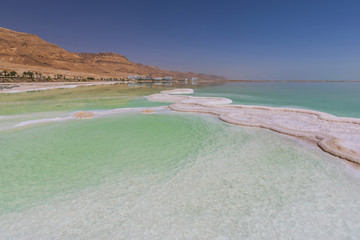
[0,84,167,116]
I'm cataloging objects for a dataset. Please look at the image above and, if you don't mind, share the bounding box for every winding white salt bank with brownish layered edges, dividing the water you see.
[147,91,360,164]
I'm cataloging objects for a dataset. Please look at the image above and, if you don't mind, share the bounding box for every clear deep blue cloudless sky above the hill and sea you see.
[0,0,360,80]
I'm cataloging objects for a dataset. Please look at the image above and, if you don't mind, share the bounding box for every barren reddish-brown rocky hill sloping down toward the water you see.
[0,27,224,80]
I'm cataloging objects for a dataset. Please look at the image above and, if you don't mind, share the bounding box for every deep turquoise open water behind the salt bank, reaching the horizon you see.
[195,82,360,118]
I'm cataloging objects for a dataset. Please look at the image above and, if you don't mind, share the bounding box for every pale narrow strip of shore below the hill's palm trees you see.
[0,82,122,93]
